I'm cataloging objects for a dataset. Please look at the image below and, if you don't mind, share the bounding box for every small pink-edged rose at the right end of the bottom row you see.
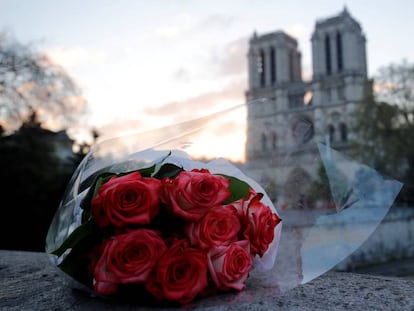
[208,240,252,291]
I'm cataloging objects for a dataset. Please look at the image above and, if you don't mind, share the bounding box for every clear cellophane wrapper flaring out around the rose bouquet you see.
[46,104,402,306]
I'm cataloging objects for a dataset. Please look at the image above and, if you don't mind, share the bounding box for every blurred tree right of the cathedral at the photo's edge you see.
[354,61,414,204]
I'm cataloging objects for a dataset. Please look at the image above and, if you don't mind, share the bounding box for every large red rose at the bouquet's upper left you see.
[91,172,161,227]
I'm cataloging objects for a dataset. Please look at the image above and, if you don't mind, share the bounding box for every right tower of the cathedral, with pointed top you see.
[310,8,367,147]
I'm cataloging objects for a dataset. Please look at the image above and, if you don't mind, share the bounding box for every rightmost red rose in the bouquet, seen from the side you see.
[244,193,280,257]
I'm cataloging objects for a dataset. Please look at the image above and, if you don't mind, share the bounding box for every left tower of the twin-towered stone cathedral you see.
[246,31,305,160]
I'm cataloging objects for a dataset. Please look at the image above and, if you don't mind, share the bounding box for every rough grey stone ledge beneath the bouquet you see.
[0,250,414,311]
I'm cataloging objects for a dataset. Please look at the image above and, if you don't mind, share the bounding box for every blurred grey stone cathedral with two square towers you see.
[246,8,369,203]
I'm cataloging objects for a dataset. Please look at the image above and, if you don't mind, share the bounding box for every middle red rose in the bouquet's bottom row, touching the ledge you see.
[145,240,207,304]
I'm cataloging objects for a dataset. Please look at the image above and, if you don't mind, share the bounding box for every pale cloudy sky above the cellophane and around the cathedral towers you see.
[0,0,414,161]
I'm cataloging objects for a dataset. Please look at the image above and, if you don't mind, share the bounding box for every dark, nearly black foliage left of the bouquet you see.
[0,112,84,251]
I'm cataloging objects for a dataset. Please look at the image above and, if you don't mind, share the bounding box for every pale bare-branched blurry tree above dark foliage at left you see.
[0,34,86,132]
